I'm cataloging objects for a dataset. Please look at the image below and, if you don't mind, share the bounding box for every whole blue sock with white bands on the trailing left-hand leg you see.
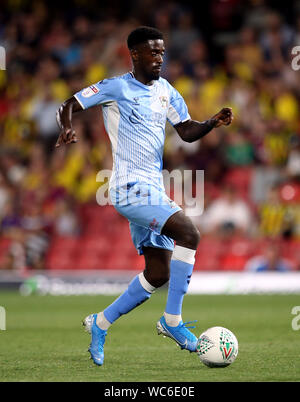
[97,273,155,329]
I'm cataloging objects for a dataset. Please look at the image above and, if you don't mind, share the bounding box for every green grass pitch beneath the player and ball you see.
[0,291,300,383]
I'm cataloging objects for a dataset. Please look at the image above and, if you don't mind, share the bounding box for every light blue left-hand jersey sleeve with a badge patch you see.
[74,78,118,109]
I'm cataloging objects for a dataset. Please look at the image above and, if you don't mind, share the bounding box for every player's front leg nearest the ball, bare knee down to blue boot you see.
[157,211,200,351]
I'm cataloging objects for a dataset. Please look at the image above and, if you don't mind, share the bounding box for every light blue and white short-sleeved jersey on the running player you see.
[74,73,190,188]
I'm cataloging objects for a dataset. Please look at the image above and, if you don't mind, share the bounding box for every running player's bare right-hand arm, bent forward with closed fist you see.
[174,107,233,142]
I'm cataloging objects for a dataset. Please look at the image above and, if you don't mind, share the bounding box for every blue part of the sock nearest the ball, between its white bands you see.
[165,260,194,315]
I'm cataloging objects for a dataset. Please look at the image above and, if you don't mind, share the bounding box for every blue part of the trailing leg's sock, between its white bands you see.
[103,275,151,323]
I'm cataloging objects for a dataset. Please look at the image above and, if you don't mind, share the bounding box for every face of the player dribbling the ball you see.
[137,39,165,80]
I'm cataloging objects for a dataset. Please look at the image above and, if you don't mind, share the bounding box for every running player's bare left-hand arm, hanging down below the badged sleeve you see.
[55,96,83,147]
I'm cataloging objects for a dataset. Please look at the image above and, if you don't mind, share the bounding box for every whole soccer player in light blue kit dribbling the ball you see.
[56,27,233,366]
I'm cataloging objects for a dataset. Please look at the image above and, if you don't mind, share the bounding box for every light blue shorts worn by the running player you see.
[110,182,181,254]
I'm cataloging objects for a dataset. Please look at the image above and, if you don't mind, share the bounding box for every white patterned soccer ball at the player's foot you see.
[197,327,238,367]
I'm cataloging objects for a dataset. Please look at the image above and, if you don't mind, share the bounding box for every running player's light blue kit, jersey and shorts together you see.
[74,73,190,254]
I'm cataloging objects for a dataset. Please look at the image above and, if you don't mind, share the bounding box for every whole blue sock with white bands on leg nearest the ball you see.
[164,245,196,326]
